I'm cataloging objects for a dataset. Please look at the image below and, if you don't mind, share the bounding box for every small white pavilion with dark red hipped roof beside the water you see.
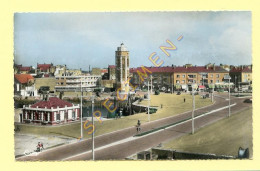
[21,97,80,125]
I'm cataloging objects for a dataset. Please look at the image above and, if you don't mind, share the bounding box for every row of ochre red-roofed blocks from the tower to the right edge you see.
[130,64,252,90]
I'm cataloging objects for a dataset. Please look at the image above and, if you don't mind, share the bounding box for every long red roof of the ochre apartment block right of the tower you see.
[130,66,228,73]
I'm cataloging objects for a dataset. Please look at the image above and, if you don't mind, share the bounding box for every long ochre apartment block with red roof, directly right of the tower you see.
[131,64,229,91]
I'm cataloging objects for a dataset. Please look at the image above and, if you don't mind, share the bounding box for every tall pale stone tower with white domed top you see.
[115,43,129,92]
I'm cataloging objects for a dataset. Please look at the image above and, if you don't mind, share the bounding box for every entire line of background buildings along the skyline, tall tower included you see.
[14,43,252,96]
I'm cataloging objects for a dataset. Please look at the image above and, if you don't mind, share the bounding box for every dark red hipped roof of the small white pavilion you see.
[31,97,73,109]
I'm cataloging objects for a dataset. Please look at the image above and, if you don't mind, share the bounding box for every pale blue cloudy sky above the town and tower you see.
[14,11,252,70]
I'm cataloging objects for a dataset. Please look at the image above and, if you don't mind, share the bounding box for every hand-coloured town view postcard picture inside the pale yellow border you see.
[13,11,255,162]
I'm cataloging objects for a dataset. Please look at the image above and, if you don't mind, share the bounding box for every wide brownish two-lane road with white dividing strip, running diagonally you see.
[16,95,252,161]
